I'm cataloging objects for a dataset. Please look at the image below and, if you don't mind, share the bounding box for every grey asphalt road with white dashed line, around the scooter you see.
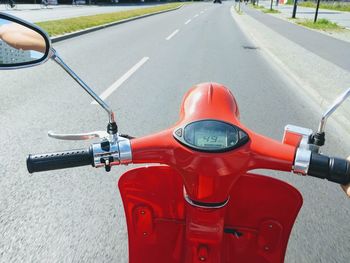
[0,2,350,262]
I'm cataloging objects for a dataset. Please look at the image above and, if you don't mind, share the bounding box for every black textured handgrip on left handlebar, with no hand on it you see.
[27,147,93,173]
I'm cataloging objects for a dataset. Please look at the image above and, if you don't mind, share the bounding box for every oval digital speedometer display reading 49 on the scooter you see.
[174,120,248,152]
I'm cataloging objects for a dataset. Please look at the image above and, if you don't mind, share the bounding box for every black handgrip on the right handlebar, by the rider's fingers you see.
[308,153,350,184]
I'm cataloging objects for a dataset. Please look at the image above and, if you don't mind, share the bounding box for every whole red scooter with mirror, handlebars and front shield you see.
[0,14,350,263]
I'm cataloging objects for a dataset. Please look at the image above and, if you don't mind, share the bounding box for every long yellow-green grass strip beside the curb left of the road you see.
[36,3,183,37]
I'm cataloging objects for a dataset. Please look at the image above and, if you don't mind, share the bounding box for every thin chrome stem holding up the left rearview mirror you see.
[51,48,115,124]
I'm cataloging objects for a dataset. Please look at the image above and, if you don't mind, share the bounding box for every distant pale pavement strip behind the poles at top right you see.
[259,0,350,29]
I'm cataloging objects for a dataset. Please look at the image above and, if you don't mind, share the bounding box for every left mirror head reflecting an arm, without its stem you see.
[0,13,51,69]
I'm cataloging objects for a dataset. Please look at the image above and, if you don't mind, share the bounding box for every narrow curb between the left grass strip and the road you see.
[51,4,184,43]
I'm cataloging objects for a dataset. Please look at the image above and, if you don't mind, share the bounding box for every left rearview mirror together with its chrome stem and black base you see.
[0,12,118,129]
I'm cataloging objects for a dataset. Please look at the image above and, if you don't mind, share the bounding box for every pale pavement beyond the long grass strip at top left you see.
[0,3,162,22]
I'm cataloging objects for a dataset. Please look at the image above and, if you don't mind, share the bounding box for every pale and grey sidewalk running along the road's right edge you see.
[232,2,350,138]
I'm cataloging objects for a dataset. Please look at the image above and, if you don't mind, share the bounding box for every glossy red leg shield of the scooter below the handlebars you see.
[119,166,302,263]
